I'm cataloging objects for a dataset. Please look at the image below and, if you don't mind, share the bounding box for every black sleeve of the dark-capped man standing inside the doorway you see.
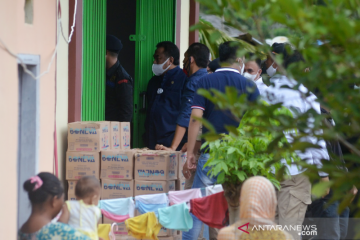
[116,79,133,122]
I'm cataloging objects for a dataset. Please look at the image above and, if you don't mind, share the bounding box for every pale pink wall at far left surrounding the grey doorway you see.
[0,0,57,236]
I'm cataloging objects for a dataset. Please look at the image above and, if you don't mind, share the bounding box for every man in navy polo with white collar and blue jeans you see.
[182,42,260,240]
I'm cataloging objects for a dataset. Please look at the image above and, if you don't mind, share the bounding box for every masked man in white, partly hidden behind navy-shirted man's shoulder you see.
[243,59,268,95]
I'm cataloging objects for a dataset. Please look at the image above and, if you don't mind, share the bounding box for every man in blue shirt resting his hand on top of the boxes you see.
[156,43,210,151]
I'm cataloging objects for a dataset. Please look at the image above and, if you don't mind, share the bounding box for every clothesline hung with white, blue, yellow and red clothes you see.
[100,188,229,239]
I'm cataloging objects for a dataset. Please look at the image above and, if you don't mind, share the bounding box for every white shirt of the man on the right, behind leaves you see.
[263,74,329,176]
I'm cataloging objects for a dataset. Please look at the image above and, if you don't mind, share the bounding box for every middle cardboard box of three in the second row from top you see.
[100,150,135,180]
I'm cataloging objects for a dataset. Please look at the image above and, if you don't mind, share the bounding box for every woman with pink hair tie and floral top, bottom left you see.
[18,172,89,240]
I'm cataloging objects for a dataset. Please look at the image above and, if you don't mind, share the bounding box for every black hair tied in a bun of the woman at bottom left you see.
[23,172,64,204]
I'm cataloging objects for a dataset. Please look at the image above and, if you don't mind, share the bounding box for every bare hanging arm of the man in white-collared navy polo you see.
[186,108,204,170]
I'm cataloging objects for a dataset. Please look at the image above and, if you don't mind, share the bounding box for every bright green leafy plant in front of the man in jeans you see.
[201,99,298,188]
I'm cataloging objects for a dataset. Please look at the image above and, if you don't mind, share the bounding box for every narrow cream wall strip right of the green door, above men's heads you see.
[180,0,190,68]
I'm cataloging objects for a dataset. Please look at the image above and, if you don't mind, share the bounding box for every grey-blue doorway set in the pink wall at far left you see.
[17,54,40,228]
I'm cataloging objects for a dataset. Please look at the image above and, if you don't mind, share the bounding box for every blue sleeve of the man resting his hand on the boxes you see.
[176,79,195,128]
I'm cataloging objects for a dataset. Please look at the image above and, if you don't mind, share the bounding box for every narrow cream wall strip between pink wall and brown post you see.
[56,0,69,184]
